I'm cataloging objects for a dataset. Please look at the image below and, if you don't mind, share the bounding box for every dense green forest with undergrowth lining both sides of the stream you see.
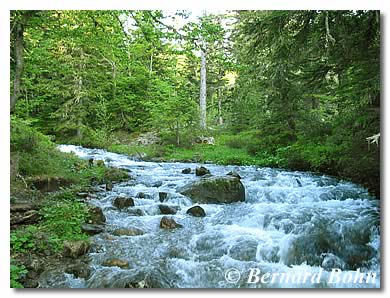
[10,10,381,287]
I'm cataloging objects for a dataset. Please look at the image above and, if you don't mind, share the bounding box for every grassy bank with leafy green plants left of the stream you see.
[10,119,128,287]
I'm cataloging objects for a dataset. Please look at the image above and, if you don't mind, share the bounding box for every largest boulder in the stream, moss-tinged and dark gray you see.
[178,176,245,204]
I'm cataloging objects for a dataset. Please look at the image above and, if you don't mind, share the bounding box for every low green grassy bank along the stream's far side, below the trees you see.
[99,131,380,197]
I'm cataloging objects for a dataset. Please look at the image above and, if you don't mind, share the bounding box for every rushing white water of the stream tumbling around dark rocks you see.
[46,145,380,288]
